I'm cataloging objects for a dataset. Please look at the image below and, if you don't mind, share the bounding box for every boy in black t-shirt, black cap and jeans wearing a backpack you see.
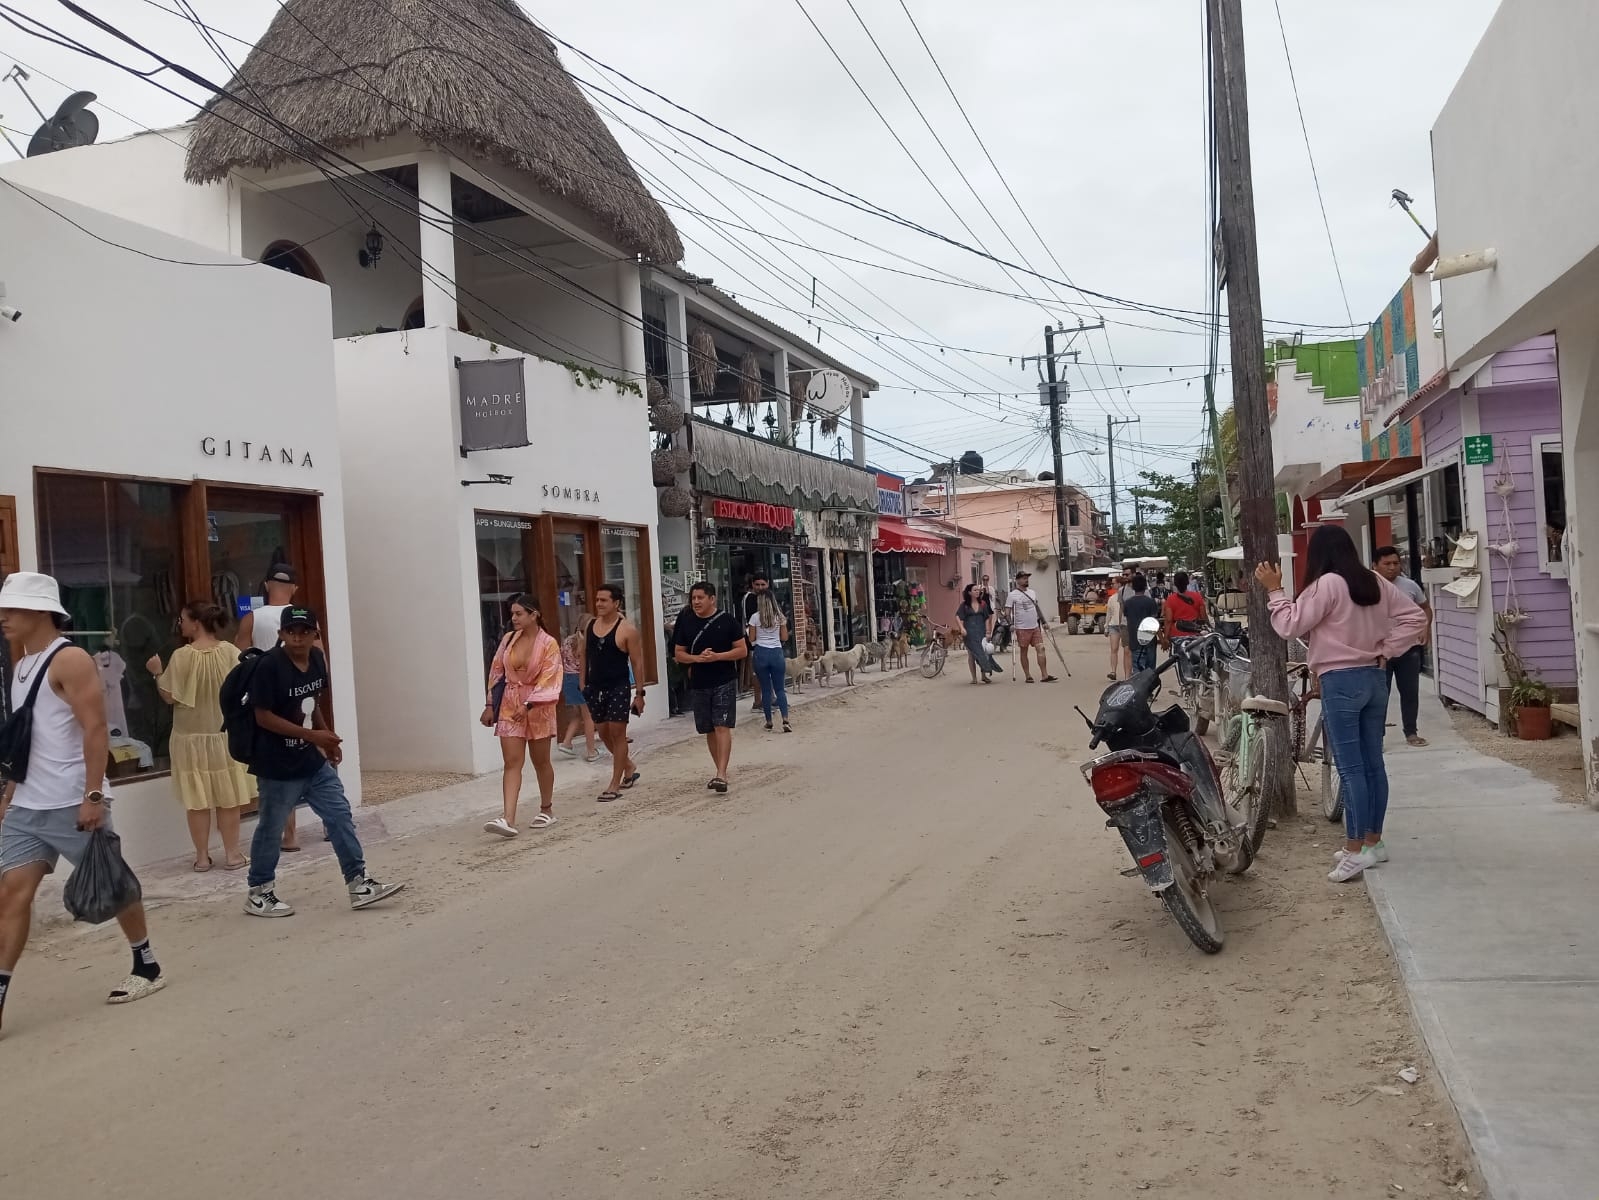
[245,606,405,917]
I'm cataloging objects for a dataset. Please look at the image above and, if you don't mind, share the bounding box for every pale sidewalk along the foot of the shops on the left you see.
[34,654,933,933]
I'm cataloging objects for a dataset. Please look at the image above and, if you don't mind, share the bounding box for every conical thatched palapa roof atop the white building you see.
[187,0,683,262]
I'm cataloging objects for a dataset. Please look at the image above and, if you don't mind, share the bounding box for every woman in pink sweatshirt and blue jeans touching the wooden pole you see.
[1255,525,1426,883]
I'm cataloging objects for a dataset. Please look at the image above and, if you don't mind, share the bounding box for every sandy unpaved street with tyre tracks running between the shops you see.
[0,634,1477,1200]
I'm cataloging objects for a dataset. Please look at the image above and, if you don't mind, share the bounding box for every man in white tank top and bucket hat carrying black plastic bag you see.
[0,571,166,1019]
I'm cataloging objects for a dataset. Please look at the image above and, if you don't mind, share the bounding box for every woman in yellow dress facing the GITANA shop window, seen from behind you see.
[147,602,256,870]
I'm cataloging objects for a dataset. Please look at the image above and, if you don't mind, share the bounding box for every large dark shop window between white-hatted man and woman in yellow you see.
[38,475,183,779]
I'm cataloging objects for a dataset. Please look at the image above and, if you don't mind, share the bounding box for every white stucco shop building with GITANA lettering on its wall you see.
[0,181,361,864]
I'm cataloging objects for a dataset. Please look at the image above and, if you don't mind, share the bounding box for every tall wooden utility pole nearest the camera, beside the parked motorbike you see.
[1206,0,1297,816]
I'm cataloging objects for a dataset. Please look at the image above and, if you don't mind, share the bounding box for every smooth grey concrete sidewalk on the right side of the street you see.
[1366,698,1599,1200]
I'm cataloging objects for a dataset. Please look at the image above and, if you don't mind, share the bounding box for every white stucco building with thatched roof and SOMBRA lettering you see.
[0,0,683,773]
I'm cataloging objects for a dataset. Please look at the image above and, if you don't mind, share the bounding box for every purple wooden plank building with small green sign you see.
[1404,334,1577,720]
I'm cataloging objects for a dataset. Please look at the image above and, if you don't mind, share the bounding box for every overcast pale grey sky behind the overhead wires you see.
[0,0,1497,504]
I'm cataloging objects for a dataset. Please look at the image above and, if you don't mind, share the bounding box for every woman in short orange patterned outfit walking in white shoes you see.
[481,594,561,837]
